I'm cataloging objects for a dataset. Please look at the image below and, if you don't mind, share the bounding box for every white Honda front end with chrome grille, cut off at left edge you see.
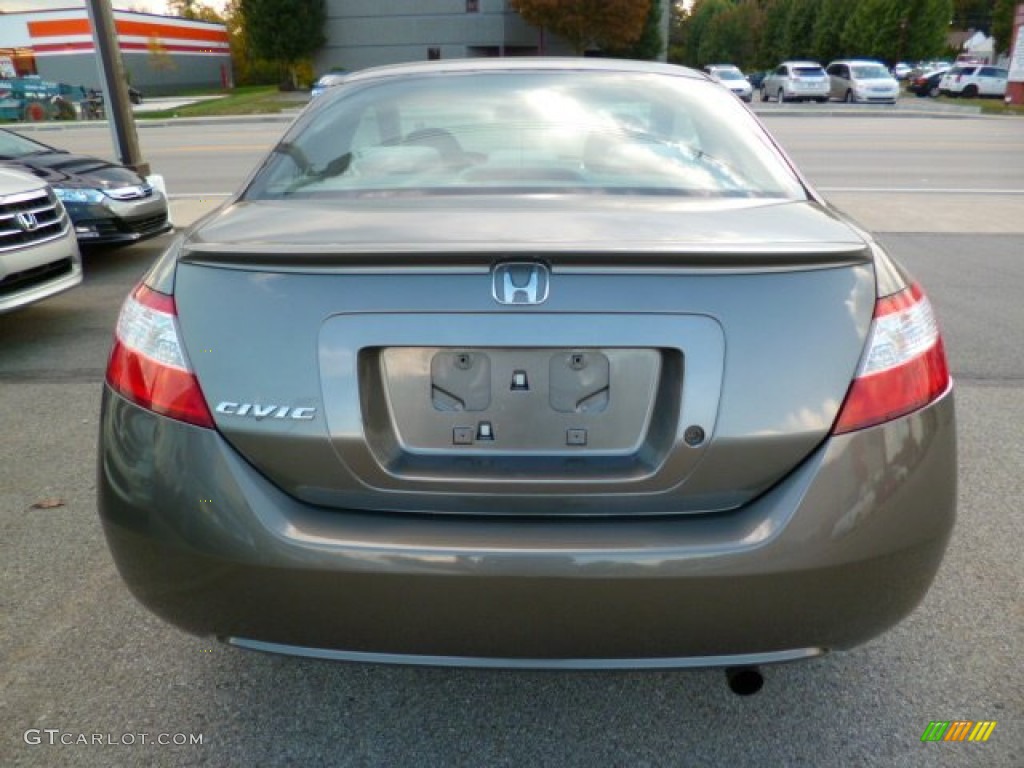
[0,168,82,312]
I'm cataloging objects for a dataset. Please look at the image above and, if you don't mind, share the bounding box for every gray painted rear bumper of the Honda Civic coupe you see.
[99,390,956,667]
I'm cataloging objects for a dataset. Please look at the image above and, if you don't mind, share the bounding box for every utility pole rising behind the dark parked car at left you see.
[86,0,150,177]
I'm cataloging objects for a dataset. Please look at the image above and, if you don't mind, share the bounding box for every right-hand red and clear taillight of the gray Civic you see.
[833,285,949,434]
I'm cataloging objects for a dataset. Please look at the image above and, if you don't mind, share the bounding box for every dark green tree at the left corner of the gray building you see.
[239,0,327,88]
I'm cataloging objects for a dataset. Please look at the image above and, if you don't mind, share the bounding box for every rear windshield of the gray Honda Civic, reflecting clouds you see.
[245,71,806,200]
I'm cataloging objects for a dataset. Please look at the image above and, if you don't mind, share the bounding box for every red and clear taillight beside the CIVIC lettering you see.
[106,285,214,428]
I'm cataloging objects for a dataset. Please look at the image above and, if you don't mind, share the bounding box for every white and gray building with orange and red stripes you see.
[0,8,231,95]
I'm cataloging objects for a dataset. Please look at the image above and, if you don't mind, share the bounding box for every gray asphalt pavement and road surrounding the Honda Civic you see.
[0,113,1024,768]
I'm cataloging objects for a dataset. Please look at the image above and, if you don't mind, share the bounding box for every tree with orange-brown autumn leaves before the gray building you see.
[511,0,650,55]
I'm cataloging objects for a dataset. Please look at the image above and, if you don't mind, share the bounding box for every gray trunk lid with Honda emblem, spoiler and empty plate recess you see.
[175,200,874,515]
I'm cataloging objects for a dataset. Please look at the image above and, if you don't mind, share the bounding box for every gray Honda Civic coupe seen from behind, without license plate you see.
[98,58,956,684]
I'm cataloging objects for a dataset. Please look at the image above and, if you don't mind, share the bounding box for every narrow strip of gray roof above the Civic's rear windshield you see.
[345,56,706,83]
